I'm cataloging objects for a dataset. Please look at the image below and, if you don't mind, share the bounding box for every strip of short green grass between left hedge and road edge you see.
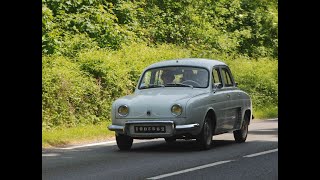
[42,122,114,148]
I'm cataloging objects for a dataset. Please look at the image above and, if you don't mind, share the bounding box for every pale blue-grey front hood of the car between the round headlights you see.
[115,87,207,119]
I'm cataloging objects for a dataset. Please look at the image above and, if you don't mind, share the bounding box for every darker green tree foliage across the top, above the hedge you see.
[42,0,278,58]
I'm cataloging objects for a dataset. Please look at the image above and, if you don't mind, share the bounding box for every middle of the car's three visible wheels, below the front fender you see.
[197,116,213,150]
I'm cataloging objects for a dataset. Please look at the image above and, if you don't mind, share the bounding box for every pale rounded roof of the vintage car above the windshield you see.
[146,58,226,69]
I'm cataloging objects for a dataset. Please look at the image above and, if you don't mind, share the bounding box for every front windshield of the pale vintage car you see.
[139,66,209,89]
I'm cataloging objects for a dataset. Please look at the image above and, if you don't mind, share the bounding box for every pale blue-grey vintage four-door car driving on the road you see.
[108,58,253,150]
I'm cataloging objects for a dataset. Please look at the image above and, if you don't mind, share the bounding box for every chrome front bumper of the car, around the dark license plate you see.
[108,121,200,138]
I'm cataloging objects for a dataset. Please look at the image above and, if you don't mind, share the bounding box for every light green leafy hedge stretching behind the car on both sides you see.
[42,43,278,129]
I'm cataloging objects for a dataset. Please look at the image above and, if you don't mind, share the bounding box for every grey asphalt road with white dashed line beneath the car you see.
[42,119,278,180]
